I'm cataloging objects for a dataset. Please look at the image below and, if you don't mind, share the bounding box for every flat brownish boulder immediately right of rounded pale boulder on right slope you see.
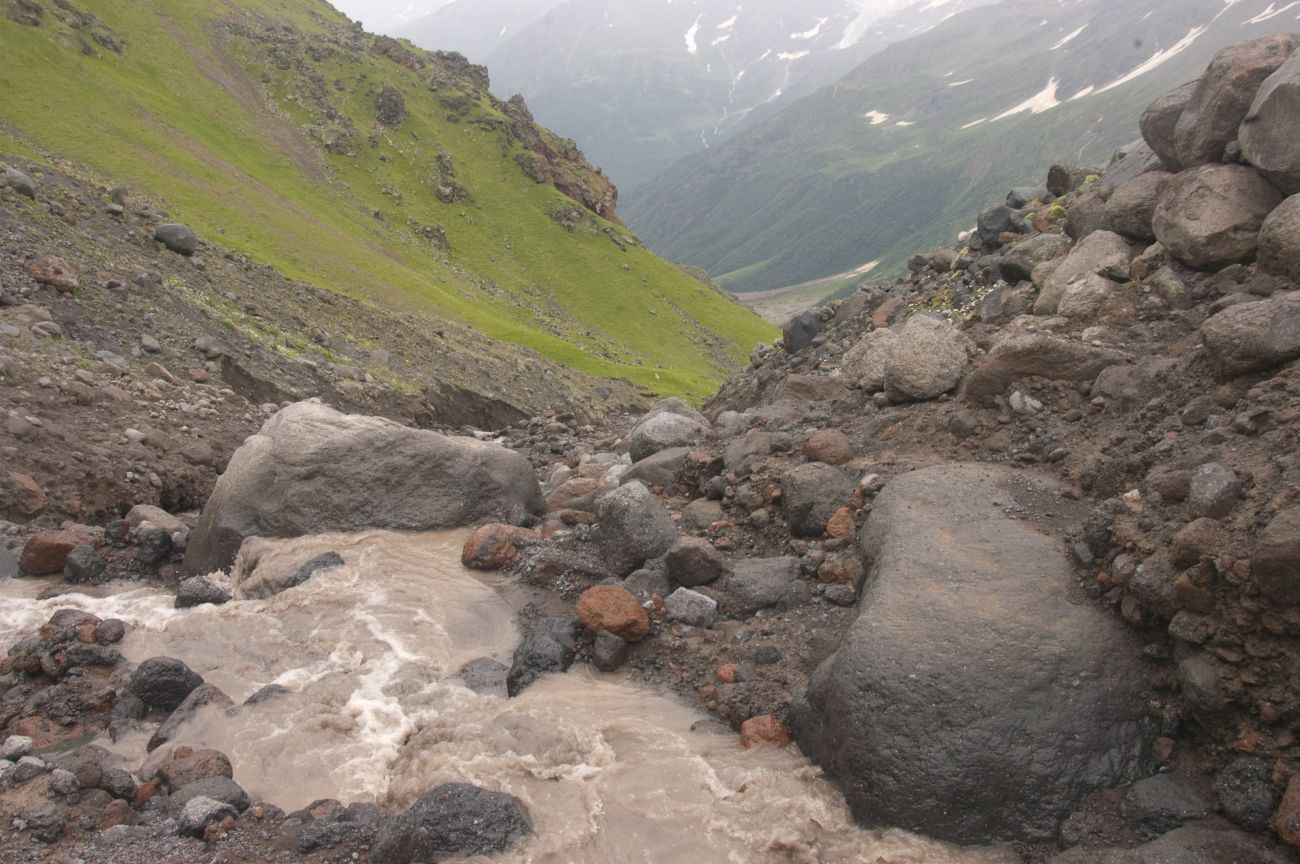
[963,330,1132,405]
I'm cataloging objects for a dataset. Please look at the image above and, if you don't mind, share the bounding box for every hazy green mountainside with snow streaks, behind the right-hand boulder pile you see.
[624,0,1300,291]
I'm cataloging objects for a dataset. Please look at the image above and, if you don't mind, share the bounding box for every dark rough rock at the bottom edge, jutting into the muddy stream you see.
[369,783,533,864]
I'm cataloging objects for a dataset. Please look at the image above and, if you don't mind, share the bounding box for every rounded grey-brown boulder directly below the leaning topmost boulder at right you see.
[1152,165,1282,270]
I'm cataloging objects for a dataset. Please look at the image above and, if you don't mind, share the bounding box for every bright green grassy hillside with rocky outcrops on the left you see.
[0,0,771,398]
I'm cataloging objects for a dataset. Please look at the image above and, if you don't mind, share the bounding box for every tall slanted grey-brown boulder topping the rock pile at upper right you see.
[1174,34,1300,168]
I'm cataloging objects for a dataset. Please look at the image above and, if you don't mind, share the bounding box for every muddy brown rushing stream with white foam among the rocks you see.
[0,531,1019,864]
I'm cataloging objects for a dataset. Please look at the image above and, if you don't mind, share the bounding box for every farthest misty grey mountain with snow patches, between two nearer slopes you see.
[402,0,992,190]
